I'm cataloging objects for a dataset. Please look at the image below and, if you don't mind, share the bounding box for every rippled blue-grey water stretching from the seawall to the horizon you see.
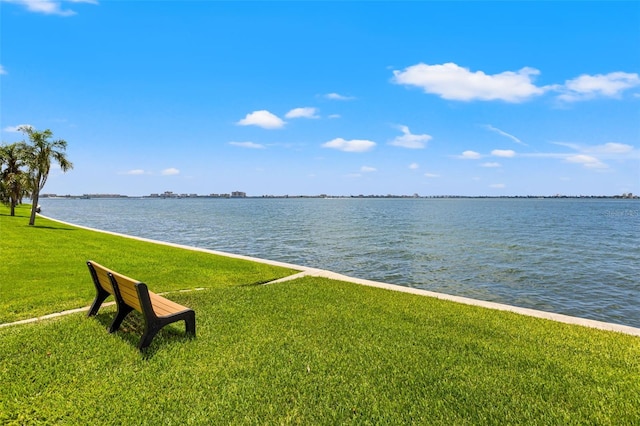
[40,199,640,327]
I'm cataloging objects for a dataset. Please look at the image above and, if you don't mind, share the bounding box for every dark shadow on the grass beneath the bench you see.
[88,311,194,359]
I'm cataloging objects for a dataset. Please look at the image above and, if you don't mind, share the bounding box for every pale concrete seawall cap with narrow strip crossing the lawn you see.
[23,216,640,336]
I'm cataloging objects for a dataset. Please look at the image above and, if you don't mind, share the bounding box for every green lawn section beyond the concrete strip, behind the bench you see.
[0,206,296,323]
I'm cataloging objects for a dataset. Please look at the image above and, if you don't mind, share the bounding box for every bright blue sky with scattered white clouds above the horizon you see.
[0,0,640,196]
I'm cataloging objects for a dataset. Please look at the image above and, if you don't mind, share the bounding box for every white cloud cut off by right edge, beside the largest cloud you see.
[558,72,640,102]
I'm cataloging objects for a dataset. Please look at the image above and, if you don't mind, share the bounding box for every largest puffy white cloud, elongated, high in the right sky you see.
[392,62,550,102]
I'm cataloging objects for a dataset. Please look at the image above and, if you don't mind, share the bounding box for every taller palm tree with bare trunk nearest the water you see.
[18,126,73,225]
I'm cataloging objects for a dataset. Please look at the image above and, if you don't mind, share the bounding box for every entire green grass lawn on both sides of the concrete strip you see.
[0,205,640,425]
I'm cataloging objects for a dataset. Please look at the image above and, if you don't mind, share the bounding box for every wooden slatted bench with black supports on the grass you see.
[87,261,196,350]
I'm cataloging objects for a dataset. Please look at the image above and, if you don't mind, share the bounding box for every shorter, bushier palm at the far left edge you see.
[0,142,28,216]
